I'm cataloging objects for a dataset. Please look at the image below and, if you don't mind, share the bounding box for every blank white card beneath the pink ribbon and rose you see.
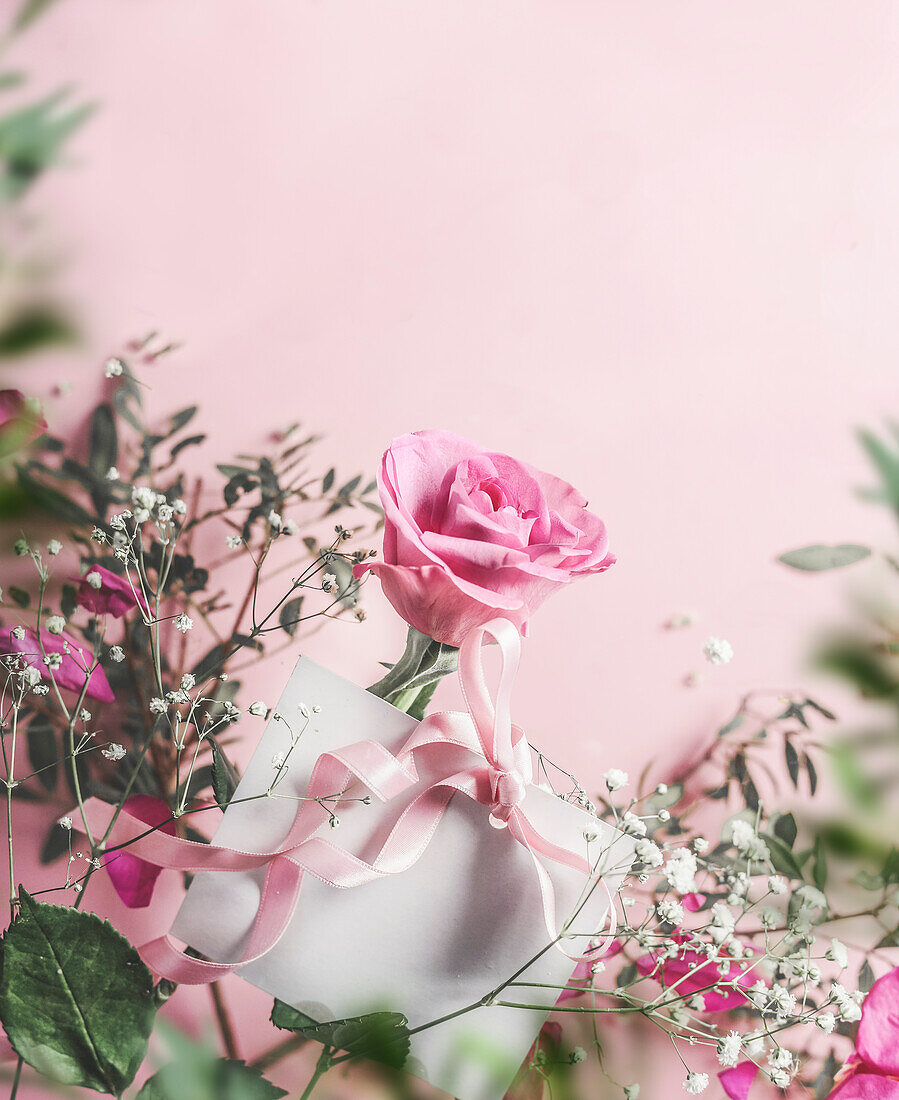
[172,658,633,1100]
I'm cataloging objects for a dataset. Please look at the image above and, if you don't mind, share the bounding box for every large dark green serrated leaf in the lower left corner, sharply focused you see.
[0,887,155,1096]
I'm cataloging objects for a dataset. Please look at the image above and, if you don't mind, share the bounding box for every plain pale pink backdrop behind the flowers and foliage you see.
[7,0,899,1095]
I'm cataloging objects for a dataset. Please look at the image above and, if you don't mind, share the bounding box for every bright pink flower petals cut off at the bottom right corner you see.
[831,967,899,1100]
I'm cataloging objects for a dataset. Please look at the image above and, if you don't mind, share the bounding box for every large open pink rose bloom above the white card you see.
[354,431,615,646]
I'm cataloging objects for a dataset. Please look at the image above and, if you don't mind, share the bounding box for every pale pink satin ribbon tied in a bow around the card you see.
[78,619,614,985]
